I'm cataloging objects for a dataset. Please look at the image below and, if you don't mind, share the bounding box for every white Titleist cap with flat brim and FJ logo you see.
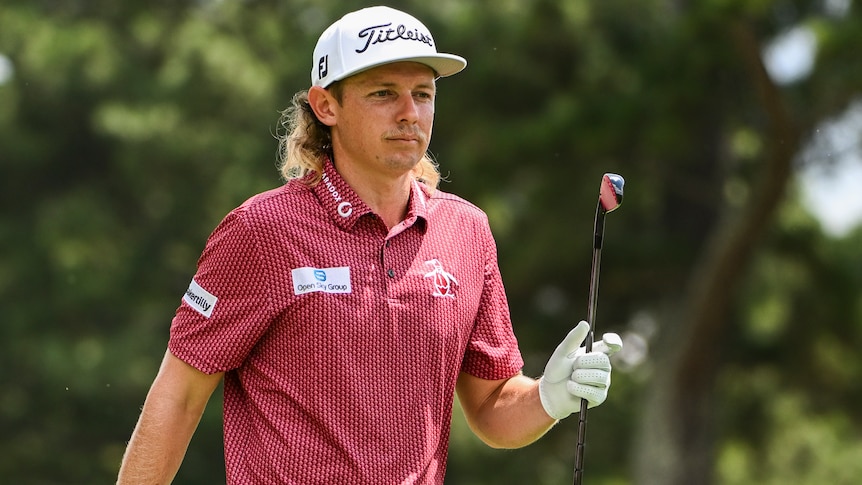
[311,7,467,88]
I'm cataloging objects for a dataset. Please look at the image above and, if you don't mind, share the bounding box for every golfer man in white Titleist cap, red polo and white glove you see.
[119,7,620,484]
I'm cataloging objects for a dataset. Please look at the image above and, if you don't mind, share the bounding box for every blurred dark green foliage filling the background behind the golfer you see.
[0,0,862,485]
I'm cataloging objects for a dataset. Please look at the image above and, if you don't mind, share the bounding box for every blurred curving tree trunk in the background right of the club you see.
[635,21,800,485]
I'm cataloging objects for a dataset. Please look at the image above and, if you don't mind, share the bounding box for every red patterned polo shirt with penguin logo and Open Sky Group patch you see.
[169,163,523,485]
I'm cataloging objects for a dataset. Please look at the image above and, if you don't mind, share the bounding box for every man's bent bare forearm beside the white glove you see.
[459,374,557,448]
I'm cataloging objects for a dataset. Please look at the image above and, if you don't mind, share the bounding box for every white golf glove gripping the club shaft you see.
[539,321,623,419]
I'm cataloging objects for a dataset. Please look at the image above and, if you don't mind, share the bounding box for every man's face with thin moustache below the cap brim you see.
[328,62,436,176]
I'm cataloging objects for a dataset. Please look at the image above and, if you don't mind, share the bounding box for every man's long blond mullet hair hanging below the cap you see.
[277,82,440,187]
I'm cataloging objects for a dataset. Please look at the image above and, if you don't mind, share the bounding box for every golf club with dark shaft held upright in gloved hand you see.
[574,173,626,485]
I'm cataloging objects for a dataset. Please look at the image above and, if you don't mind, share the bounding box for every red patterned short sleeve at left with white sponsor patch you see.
[168,208,272,373]
